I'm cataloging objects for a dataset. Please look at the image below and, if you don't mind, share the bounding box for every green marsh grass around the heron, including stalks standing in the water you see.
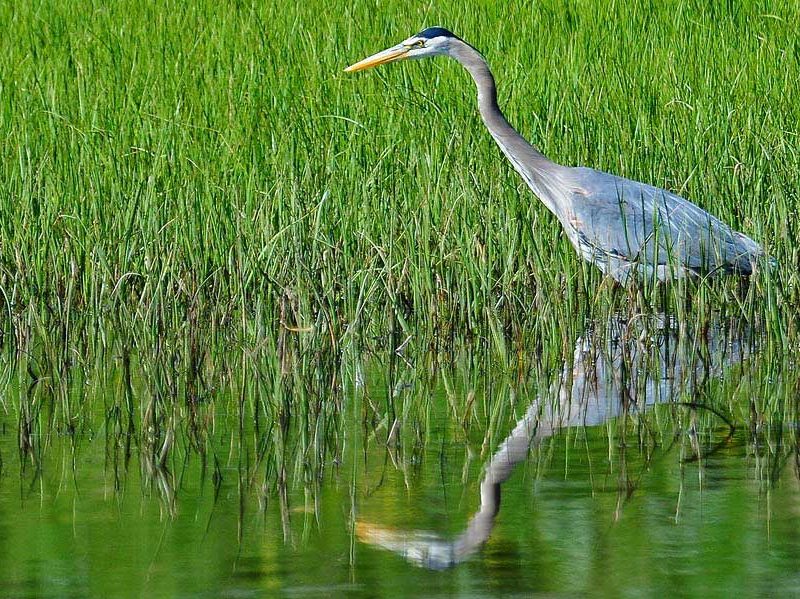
[0,0,800,508]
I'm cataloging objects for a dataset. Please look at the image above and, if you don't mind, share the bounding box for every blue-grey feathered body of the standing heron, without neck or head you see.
[541,167,763,283]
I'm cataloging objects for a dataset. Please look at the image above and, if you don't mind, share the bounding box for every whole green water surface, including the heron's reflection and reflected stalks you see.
[0,316,800,597]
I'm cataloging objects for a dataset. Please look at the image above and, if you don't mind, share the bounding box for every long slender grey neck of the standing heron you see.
[450,41,562,215]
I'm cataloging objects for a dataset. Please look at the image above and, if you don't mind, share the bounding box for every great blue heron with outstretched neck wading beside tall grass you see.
[345,27,773,284]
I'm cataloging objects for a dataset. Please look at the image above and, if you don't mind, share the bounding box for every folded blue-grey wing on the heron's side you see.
[572,168,762,274]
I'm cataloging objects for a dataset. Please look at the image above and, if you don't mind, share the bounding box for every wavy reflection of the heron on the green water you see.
[356,317,754,569]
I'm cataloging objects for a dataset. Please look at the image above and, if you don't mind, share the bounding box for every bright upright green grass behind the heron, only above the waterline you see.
[0,1,800,352]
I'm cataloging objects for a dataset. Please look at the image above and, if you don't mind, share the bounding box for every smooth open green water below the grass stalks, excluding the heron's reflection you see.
[6,438,800,597]
